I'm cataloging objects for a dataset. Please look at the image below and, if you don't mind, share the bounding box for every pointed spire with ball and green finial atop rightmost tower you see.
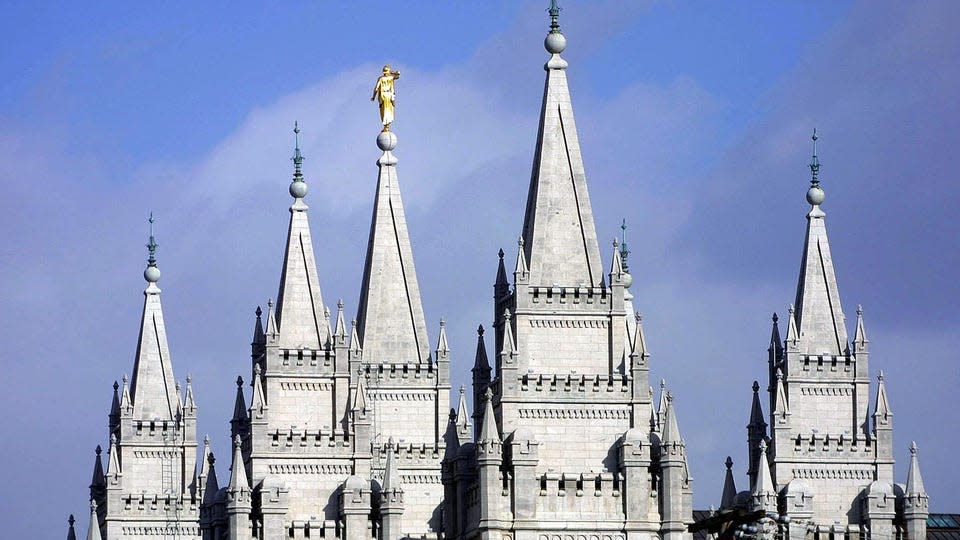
[796,131,847,354]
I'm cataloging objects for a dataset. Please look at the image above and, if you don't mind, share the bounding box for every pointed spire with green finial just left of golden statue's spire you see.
[267,126,324,349]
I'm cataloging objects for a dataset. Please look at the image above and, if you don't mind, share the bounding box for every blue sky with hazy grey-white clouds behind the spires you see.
[0,0,960,537]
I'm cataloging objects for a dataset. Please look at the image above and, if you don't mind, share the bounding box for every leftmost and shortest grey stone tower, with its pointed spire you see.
[88,221,200,539]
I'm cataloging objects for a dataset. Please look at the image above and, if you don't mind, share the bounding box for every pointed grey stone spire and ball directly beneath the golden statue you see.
[357,131,430,362]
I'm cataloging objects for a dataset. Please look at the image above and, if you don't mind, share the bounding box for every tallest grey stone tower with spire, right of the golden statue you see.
[444,2,692,540]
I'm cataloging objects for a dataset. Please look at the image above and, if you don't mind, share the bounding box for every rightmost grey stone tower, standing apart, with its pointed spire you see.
[721,133,926,539]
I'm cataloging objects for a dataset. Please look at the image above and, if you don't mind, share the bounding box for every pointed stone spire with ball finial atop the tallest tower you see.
[523,6,603,286]
